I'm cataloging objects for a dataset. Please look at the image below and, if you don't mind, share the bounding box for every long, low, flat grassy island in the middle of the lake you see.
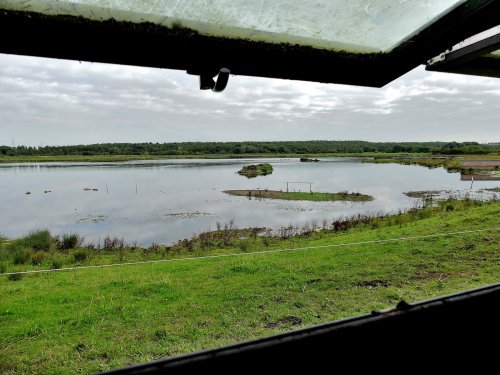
[224,189,374,202]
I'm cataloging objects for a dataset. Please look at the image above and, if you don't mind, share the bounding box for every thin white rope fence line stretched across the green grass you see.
[0,228,500,276]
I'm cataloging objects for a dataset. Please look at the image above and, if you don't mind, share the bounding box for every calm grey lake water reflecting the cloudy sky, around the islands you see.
[0,158,499,245]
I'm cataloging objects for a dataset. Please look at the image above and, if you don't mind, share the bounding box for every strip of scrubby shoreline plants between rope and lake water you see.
[0,198,498,276]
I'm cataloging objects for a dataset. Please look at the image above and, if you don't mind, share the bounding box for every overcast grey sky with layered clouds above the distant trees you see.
[0,54,500,146]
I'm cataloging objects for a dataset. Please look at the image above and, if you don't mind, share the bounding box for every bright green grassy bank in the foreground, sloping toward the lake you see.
[0,200,500,374]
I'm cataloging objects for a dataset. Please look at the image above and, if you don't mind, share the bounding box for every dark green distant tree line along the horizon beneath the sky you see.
[0,141,500,156]
